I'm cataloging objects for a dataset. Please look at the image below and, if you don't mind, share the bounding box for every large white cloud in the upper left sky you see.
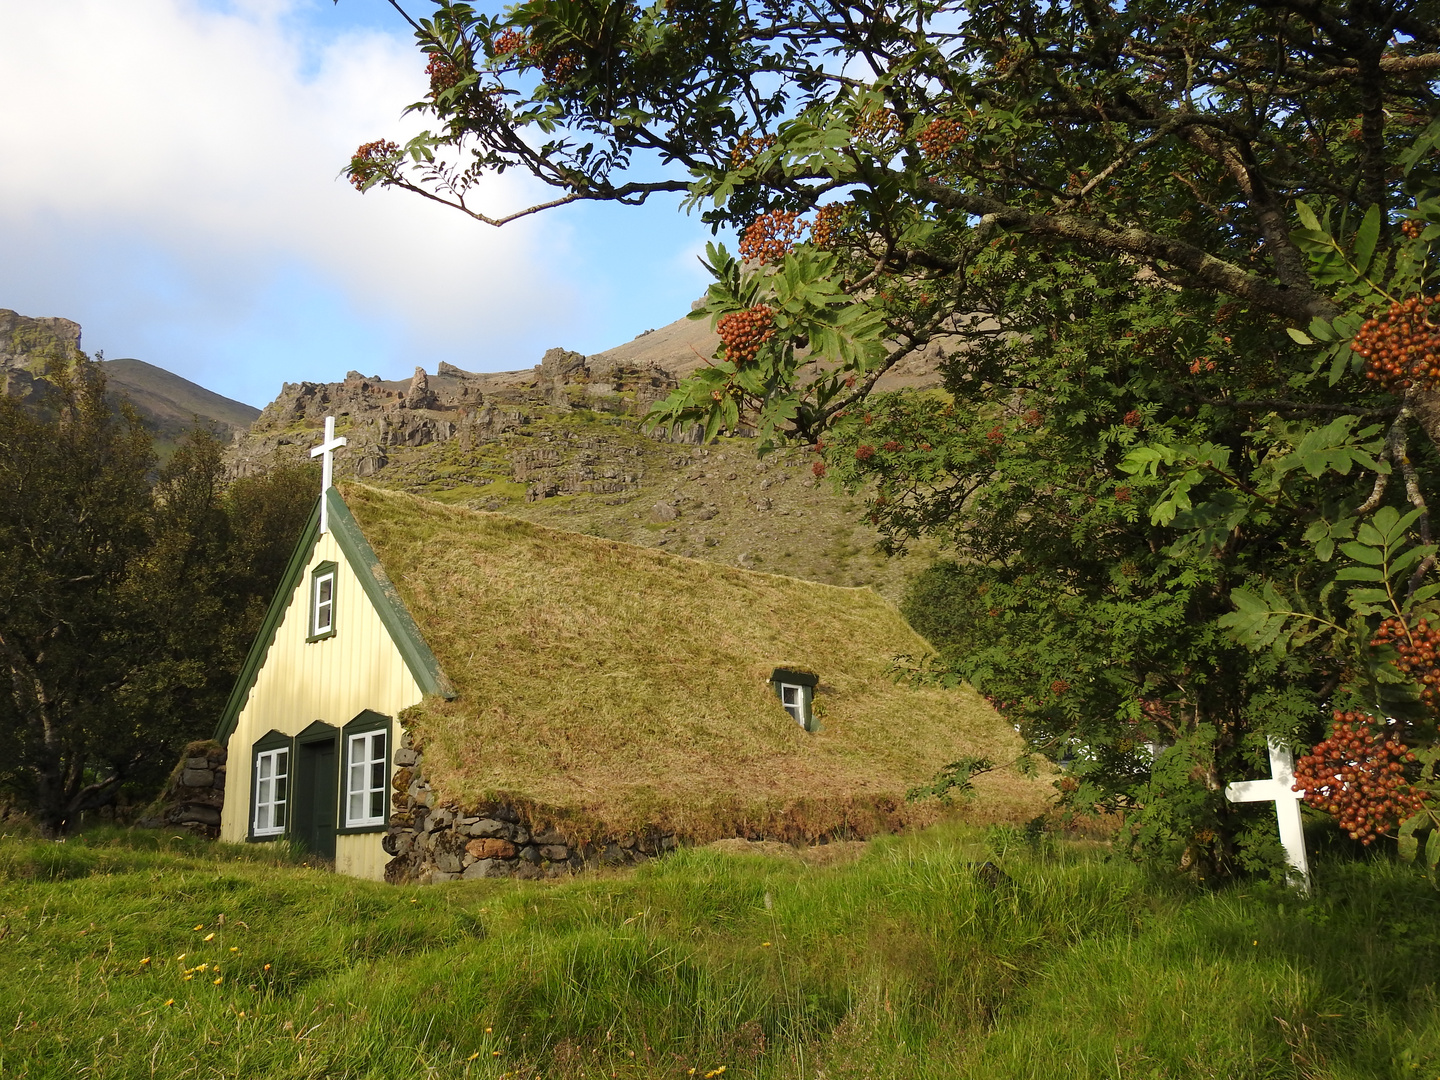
[0,0,567,403]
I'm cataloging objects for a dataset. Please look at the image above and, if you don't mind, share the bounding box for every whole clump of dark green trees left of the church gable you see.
[0,357,314,834]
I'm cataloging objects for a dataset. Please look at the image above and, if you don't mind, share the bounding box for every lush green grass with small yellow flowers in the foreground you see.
[0,827,1440,1080]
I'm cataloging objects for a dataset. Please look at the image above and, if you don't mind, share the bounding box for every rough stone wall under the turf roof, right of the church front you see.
[383,730,678,884]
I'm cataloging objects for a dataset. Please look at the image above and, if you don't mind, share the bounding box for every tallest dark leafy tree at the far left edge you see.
[0,361,154,831]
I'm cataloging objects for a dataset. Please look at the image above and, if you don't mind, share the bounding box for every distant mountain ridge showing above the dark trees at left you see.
[0,308,261,455]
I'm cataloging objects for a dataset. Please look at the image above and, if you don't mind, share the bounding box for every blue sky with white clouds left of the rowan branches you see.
[0,0,708,406]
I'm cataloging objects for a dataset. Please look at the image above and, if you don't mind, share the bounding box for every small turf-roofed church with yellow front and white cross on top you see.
[216,418,1037,878]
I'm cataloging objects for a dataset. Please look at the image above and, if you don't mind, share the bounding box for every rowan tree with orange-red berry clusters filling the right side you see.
[350,0,1440,870]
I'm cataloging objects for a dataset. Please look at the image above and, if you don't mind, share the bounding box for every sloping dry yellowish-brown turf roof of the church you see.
[343,485,1045,840]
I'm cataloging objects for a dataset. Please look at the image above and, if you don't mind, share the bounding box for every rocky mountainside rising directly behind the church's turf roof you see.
[232,311,937,598]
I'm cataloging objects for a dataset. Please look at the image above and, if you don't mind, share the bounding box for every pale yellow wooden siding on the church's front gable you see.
[220,533,422,877]
